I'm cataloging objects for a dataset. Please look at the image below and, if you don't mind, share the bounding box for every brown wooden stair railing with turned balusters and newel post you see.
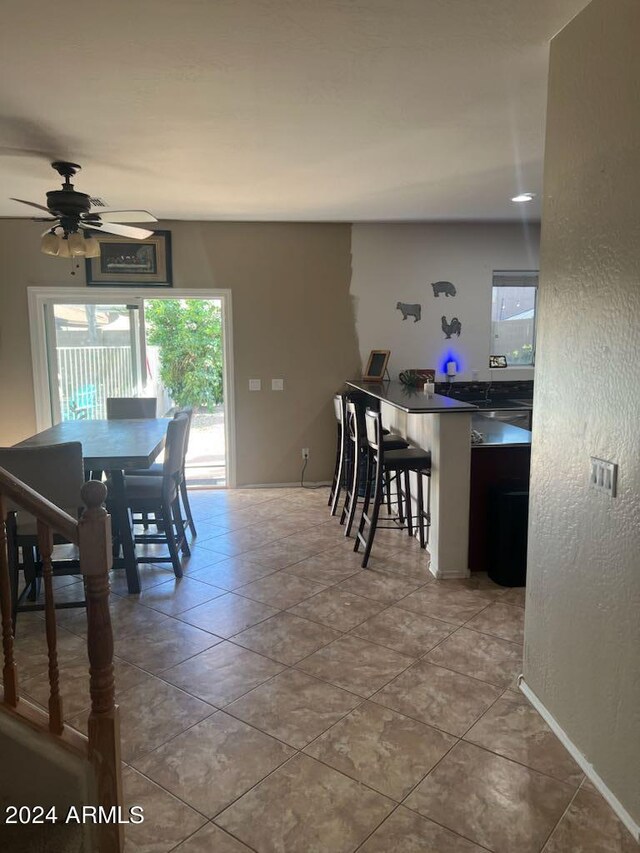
[0,468,124,853]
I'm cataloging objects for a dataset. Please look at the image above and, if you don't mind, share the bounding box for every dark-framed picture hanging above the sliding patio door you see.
[85,231,173,287]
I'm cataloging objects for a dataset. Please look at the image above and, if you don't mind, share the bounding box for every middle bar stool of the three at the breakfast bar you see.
[340,401,409,536]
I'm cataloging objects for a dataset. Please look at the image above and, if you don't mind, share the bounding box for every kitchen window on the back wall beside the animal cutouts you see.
[491,272,538,367]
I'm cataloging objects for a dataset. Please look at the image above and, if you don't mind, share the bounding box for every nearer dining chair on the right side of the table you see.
[125,414,191,578]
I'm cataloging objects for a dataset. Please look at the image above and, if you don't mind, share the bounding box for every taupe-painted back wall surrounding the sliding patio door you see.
[0,219,360,485]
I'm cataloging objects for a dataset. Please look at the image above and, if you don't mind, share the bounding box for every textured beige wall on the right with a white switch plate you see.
[525,0,640,823]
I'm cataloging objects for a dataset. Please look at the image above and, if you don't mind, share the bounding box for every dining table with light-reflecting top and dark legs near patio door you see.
[15,418,169,593]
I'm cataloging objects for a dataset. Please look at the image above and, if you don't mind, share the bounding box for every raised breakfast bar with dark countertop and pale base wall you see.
[347,380,478,578]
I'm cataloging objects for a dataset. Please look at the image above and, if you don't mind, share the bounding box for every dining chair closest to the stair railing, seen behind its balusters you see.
[0,441,85,626]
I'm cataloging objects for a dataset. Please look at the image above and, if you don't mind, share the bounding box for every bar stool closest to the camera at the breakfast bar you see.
[353,409,431,569]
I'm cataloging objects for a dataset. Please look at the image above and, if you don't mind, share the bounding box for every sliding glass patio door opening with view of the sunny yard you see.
[30,288,233,487]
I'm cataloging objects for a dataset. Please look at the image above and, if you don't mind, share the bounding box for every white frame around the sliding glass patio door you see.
[27,286,236,488]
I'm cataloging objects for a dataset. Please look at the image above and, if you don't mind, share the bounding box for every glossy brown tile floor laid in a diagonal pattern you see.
[12,489,638,853]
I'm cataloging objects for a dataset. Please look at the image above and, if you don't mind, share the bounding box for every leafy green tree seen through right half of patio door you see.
[145,299,223,409]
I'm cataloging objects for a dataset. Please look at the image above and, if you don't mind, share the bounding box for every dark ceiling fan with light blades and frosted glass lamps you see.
[11,160,158,258]
